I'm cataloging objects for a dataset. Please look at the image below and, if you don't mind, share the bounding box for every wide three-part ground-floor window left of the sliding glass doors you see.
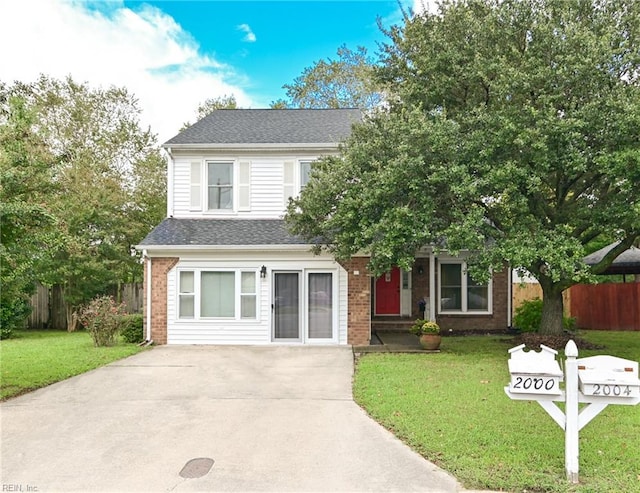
[178,270,258,320]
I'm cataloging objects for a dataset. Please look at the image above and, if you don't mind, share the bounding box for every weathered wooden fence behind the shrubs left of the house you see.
[27,283,144,329]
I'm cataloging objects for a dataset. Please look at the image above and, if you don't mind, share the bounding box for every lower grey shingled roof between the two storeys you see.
[139,217,308,247]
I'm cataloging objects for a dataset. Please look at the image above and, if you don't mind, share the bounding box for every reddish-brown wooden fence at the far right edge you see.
[570,282,640,330]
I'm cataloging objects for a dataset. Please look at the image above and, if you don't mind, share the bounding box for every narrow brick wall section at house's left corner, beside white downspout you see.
[143,257,179,344]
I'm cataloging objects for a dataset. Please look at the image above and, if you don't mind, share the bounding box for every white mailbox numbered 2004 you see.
[577,356,640,403]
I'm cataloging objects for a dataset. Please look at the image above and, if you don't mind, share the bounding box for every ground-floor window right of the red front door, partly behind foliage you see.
[439,262,491,313]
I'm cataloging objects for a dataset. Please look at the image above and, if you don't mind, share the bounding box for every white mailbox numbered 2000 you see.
[509,344,563,395]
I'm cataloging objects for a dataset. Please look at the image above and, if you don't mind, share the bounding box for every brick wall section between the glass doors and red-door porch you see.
[342,257,371,346]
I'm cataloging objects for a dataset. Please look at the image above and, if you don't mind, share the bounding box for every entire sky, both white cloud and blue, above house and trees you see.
[0,0,422,142]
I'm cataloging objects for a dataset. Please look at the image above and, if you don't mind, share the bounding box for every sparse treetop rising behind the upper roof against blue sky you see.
[280,45,382,109]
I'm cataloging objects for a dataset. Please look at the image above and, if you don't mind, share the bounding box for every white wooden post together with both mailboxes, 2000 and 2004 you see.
[504,341,640,483]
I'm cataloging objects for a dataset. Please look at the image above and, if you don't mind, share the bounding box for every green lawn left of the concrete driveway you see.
[0,330,144,400]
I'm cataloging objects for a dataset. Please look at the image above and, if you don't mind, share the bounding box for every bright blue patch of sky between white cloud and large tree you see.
[125,0,400,106]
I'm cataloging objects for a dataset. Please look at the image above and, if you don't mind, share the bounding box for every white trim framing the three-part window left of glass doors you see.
[176,267,260,323]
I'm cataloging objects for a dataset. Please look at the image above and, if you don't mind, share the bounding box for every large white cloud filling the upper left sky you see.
[0,0,253,142]
